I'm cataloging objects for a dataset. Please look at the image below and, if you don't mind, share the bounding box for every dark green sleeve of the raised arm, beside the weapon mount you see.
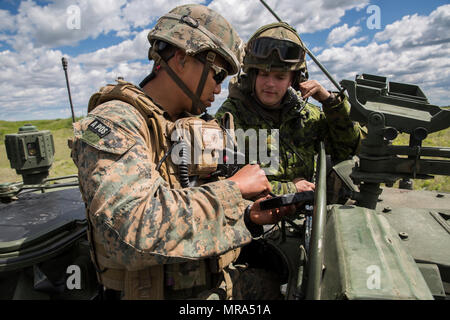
[322,93,360,163]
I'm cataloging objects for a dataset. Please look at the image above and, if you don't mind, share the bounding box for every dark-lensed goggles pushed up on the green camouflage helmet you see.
[248,37,305,63]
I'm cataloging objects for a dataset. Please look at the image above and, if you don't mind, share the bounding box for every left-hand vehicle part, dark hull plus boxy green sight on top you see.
[0,125,98,300]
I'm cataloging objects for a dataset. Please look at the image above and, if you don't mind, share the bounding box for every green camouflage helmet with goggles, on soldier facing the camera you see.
[243,22,308,90]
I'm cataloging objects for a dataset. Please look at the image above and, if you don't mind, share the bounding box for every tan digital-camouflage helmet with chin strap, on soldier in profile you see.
[147,4,243,111]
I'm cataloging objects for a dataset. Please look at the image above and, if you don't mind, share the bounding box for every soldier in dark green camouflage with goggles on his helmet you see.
[216,23,360,194]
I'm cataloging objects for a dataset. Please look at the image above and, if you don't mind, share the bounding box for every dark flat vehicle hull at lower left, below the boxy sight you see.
[0,188,98,299]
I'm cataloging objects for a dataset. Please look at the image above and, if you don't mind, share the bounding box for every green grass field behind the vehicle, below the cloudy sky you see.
[0,118,450,192]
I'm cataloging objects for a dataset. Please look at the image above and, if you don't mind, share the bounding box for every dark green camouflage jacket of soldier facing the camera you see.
[215,79,360,194]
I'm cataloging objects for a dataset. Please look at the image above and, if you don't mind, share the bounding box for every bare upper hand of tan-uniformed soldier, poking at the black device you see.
[227,164,272,200]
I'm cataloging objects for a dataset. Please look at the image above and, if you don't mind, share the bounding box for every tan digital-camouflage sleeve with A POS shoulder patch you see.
[72,101,251,269]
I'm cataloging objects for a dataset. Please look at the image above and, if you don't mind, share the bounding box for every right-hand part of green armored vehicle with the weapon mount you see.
[240,74,450,299]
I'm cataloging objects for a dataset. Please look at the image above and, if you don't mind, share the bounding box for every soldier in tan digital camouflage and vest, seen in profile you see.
[72,5,294,299]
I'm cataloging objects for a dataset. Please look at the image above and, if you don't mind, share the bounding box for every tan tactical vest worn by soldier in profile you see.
[83,80,240,300]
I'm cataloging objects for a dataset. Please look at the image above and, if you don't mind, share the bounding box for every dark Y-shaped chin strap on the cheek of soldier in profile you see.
[150,48,211,114]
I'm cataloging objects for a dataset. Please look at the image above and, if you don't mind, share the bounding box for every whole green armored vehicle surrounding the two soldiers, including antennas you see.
[0,0,450,300]
